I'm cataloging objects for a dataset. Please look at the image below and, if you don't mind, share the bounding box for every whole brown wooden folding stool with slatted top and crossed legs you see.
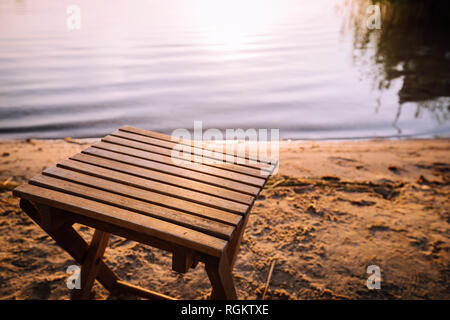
[14,126,277,299]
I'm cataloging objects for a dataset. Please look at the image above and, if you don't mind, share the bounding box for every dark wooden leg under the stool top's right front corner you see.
[205,253,237,300]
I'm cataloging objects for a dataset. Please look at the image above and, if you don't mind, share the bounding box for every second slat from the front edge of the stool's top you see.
[30,172,237,240]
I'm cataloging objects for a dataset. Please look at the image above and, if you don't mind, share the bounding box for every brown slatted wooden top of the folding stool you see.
[14,126,274,261]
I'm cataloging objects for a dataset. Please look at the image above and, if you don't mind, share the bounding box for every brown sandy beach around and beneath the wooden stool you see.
[0,140,450,299]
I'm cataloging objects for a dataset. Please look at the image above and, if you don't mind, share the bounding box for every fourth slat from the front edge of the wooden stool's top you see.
[58,159,249,214]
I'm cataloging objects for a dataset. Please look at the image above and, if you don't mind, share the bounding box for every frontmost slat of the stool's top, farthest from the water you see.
[14,184,227,257]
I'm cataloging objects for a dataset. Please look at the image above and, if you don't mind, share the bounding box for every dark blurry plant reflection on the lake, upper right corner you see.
[338,0,450,133]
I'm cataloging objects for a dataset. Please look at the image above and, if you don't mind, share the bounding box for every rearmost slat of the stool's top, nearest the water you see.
[111,130,272,172]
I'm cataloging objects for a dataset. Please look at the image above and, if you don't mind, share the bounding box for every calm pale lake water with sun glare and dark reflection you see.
[0,0,450,139]
